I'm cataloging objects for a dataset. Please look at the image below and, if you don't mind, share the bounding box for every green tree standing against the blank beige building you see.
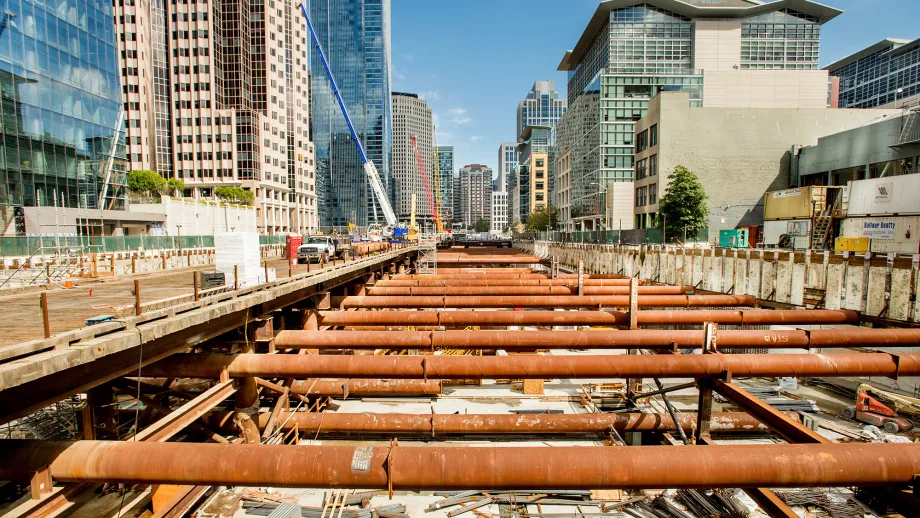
[655,165,709,243]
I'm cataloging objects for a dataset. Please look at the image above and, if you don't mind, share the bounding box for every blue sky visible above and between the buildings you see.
[391,0,920,175]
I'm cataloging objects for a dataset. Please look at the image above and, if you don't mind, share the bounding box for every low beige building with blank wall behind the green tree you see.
[634,92,895,238]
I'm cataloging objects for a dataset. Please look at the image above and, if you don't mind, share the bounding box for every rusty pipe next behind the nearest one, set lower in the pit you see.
[253,412,784,435]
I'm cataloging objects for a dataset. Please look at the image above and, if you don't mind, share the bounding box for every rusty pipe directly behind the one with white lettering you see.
[319,309,859,327]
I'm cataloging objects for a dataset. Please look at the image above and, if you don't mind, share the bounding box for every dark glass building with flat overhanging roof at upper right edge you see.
[824,38,920,108]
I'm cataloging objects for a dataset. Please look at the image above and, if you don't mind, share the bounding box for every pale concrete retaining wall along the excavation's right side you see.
[515,241,920,322]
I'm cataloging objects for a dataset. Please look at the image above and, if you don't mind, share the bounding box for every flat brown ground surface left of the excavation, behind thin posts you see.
[0,258,338,345]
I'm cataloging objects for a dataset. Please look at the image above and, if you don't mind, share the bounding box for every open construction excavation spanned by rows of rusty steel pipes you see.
[0,241,920,518]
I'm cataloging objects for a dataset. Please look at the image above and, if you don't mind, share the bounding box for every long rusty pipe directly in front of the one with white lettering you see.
[144,353,920,379]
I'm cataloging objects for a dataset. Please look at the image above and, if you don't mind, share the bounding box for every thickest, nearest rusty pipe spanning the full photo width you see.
[0,439,920,490]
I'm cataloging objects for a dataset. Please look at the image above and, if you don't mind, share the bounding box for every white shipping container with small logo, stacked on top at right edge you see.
[847,174,920,217]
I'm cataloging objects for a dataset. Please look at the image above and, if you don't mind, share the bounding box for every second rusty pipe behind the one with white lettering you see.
[342,295,755,309]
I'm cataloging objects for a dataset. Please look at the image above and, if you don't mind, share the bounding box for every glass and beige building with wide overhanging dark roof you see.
[556,0,841,230]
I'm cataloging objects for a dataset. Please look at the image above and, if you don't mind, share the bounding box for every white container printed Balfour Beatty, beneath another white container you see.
[841,216,920,254]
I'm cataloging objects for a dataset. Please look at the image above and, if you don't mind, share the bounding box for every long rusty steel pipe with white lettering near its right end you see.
[275,329,828,351]
